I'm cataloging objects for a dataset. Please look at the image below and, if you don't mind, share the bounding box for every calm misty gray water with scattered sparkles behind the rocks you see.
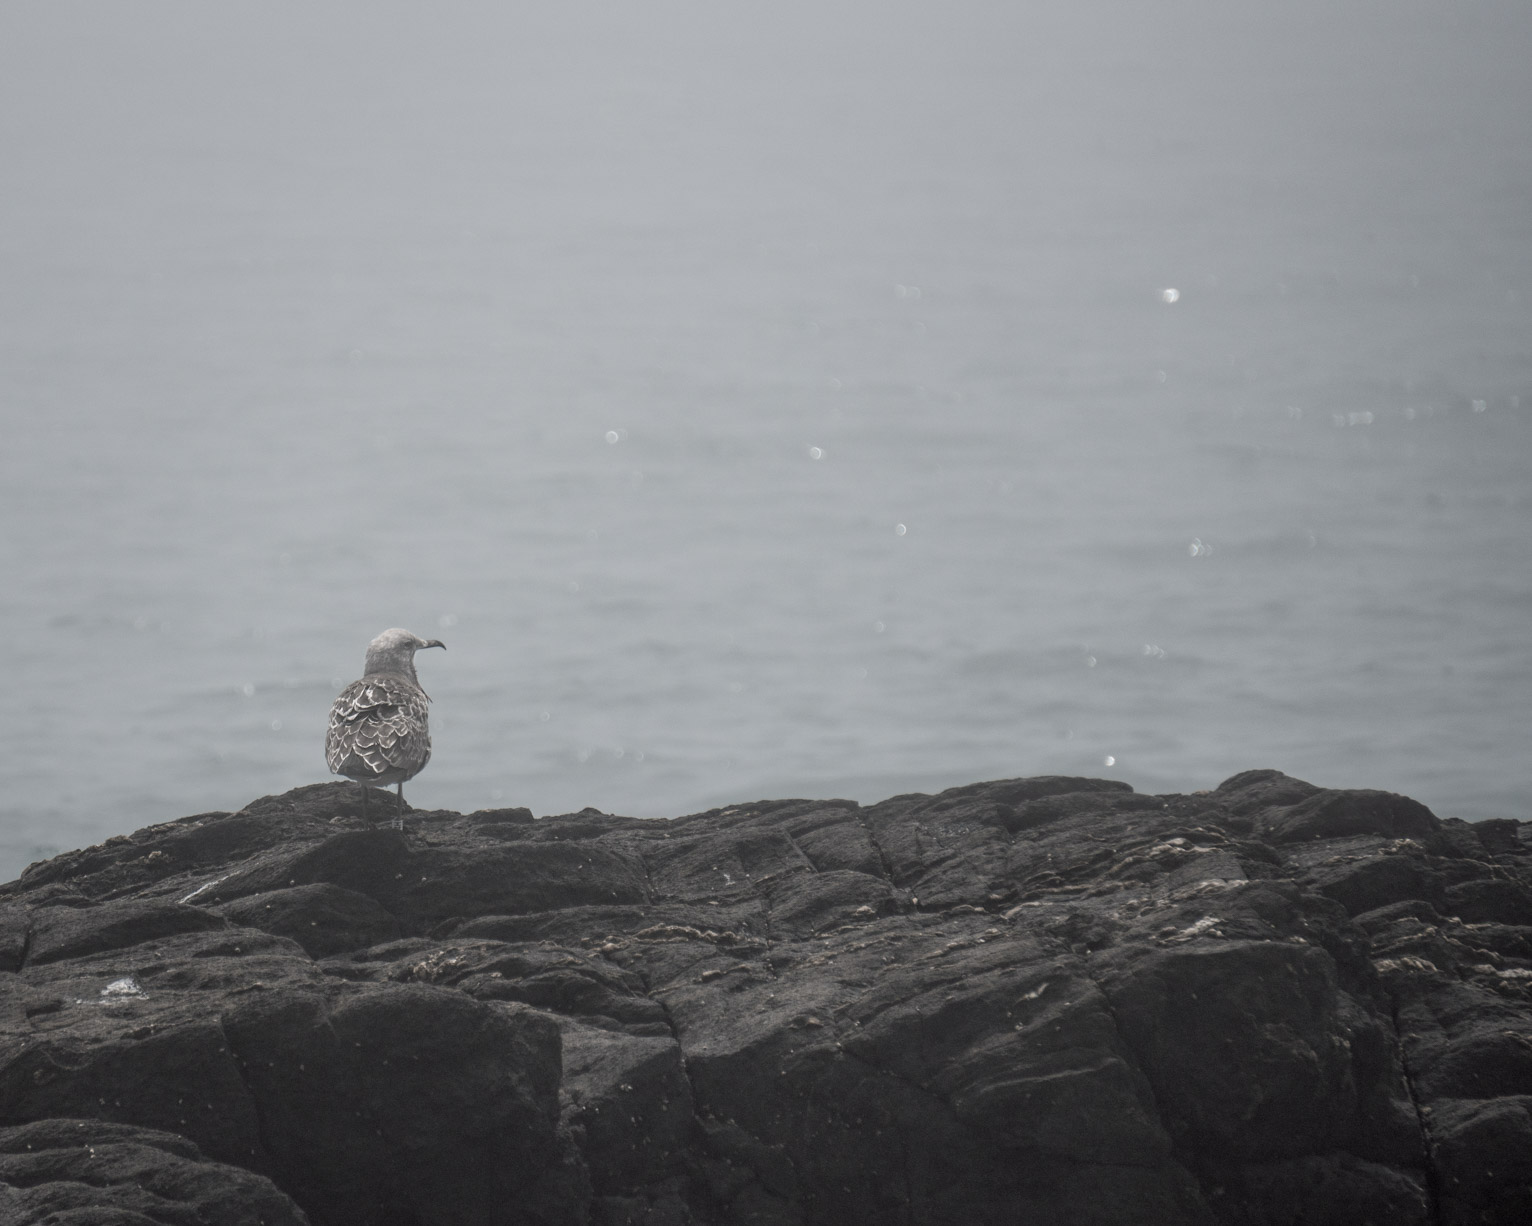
[0,0,1532,877]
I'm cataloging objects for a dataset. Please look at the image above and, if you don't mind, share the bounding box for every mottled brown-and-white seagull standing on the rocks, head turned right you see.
[325,628,447,831]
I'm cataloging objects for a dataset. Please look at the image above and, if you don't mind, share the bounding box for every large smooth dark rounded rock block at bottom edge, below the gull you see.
[224,985,559,1224]
